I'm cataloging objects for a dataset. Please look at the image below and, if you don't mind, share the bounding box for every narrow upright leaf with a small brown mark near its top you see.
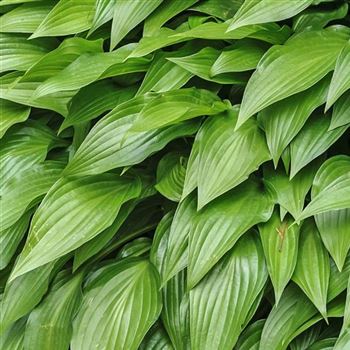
[259,210,299,304]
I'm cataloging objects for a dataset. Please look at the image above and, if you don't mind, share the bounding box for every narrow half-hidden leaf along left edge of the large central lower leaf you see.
[162,193,196,283]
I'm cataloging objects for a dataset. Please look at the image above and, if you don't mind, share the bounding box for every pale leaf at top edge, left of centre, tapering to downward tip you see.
[110,0,163,50]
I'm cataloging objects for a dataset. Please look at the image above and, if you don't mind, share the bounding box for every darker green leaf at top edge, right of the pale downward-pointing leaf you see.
[143,0,198,36]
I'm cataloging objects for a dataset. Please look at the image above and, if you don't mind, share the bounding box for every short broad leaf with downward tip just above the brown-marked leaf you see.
[263,160,320,219]
